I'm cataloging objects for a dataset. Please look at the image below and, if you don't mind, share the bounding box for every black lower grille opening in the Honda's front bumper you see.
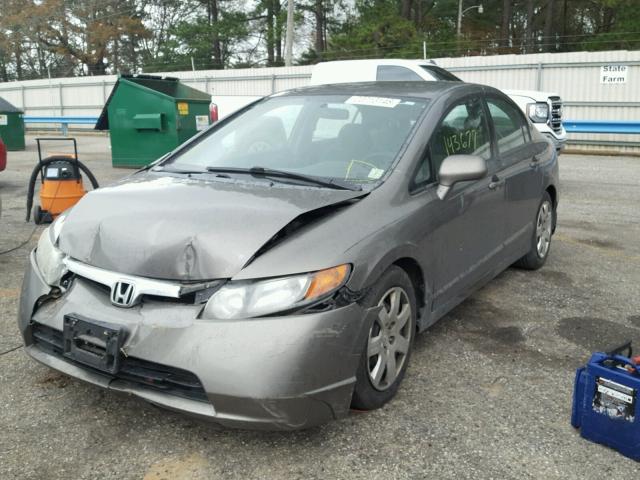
[31,323,208,402]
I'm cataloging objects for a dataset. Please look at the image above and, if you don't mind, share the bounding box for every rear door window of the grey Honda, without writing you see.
[487,98,529,163]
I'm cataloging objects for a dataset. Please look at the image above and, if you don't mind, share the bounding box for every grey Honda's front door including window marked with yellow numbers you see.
[414,94,504,318]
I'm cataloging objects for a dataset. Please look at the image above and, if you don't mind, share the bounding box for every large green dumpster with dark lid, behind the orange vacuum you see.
[95,75,211,167]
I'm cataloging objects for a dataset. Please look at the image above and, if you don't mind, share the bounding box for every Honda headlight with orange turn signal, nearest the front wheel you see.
[202,265,351,320]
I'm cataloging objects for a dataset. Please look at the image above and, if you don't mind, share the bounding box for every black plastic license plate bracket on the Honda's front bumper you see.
[62,315,125,375]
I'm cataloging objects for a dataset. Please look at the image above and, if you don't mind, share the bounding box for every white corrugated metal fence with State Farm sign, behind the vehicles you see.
[0,51,640,152]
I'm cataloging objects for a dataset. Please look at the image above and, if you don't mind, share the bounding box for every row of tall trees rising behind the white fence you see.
[0,0,640,81]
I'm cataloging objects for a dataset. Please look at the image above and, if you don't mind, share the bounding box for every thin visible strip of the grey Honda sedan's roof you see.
[275,81,480,99]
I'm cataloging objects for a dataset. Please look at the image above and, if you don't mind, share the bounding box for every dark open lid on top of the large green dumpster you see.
[94,75,211,130]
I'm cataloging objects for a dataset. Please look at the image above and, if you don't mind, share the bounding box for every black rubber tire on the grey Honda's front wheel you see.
[351,265,417,410]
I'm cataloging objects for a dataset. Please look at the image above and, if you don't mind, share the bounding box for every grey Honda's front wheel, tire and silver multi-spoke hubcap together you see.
[351,265,416,410]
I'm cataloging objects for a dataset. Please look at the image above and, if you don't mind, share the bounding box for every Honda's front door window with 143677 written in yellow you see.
[429,97,491,172]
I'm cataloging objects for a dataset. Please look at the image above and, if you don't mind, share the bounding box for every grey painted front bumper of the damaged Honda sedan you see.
[18,253,377,429]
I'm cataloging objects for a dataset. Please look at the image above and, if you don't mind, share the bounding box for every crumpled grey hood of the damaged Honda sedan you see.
[59,173,363,281]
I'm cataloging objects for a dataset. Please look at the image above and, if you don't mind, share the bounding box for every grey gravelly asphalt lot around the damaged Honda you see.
[0,137,640,479]
